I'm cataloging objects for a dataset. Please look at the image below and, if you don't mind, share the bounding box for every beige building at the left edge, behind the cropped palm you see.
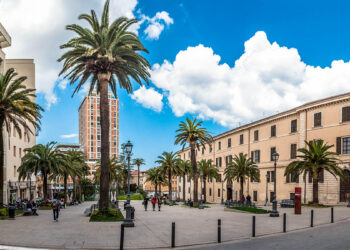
[0,24,38,204]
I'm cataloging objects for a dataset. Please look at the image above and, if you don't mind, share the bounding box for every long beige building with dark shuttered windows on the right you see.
[177,93,350,204]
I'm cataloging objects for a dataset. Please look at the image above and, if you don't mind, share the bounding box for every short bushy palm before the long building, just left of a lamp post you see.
[224,154,260,197]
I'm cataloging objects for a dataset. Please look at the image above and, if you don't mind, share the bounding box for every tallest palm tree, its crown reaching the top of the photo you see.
[58,0,150,212]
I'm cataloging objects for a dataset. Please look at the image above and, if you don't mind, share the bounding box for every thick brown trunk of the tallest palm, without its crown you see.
[98,72,111,213]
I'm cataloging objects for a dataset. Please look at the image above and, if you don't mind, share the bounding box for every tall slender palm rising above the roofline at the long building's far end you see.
[175,118,213,204]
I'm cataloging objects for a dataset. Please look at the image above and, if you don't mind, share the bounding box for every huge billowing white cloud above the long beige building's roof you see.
[152,31,350,127]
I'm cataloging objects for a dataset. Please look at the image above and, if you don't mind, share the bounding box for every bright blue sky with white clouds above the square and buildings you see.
[0,0,350,169]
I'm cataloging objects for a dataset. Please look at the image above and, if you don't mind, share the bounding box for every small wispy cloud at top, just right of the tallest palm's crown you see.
[141,11,174,40]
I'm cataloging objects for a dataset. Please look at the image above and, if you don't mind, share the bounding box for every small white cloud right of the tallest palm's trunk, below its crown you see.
[131,86,163,112]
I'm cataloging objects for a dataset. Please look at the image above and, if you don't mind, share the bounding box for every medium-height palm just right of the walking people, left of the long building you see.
[156,152,179,203]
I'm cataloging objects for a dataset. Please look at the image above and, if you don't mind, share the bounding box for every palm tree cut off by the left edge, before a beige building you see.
[0,68,43,205]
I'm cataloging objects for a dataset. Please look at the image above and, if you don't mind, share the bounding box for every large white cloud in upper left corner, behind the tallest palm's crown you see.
[0,0,169,108]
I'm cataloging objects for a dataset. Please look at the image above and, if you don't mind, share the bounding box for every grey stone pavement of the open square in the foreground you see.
[0,201,350,249]
